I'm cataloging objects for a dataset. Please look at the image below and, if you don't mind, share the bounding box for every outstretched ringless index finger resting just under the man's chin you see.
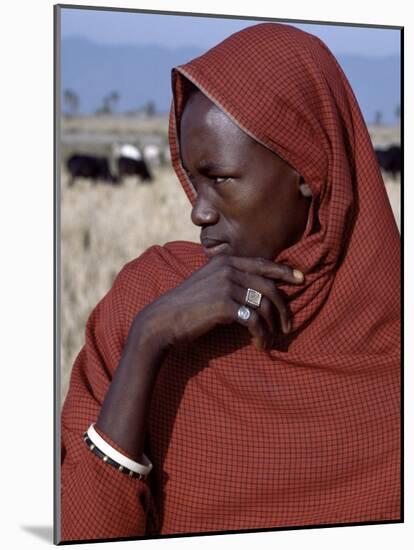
[223,256,305,284]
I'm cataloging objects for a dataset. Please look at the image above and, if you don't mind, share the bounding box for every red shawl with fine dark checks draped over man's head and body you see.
[61,23,400,540]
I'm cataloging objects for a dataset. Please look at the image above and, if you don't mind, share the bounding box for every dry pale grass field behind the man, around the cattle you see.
[60,120,400,403]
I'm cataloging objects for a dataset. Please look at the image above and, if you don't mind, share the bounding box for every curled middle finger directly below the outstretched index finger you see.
[230,268,290,334]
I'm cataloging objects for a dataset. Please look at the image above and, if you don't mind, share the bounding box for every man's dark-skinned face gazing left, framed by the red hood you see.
[180,92,310,260]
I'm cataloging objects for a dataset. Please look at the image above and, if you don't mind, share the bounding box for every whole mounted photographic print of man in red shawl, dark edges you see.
[55,5,403,544]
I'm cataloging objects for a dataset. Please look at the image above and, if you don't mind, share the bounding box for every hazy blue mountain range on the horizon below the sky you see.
[61,37,400,124]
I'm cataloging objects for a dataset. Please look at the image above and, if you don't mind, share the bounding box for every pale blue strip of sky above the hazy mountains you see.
[61,8,400,57]
